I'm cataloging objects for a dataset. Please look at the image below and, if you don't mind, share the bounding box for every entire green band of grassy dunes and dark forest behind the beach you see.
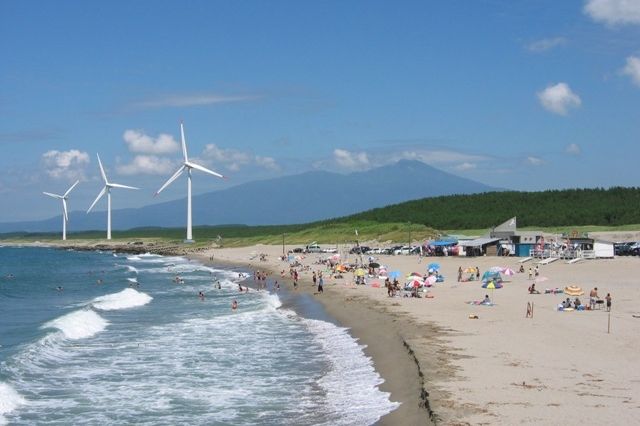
[2,188,640,247]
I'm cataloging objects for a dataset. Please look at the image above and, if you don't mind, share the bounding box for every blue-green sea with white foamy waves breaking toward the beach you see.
[0,247,398,425]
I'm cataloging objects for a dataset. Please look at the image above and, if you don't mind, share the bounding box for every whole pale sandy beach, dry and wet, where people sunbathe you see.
[199,246,640,425]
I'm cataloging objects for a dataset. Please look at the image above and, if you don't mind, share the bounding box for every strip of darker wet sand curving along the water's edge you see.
[10,242,438,426]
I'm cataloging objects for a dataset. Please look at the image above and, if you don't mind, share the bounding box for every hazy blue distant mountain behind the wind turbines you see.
[0,160,498,232]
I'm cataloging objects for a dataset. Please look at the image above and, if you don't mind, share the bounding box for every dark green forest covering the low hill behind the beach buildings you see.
[335,187,640,229]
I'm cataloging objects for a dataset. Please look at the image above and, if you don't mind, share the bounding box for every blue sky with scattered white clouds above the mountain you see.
[0,0,640,222]
